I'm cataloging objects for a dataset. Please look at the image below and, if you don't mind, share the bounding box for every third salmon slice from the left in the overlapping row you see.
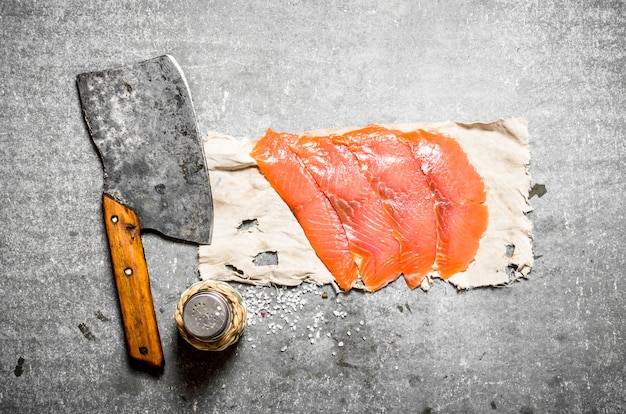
[332,125,437,289]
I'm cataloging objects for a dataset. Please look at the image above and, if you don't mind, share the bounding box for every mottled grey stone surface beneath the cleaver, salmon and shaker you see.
[0,0,626,413]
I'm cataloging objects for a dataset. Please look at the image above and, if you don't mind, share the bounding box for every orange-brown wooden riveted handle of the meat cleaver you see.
[102,194,164,368]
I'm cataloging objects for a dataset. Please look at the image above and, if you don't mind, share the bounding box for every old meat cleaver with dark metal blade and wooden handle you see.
[77,55,213,368]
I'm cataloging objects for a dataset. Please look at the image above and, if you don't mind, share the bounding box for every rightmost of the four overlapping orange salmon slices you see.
[402,130,489,279]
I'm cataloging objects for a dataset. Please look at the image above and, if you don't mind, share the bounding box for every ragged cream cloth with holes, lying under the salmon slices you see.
[198,118,533,290]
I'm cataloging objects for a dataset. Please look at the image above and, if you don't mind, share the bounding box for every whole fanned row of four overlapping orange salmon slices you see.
[251,125,489,291]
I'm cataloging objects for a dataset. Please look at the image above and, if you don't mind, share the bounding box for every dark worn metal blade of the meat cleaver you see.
[77,55,213,244]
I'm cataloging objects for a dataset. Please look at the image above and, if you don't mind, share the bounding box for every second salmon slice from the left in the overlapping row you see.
[290,136,402,291]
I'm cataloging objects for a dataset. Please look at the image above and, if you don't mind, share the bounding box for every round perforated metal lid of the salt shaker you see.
[183,291,232,342]
